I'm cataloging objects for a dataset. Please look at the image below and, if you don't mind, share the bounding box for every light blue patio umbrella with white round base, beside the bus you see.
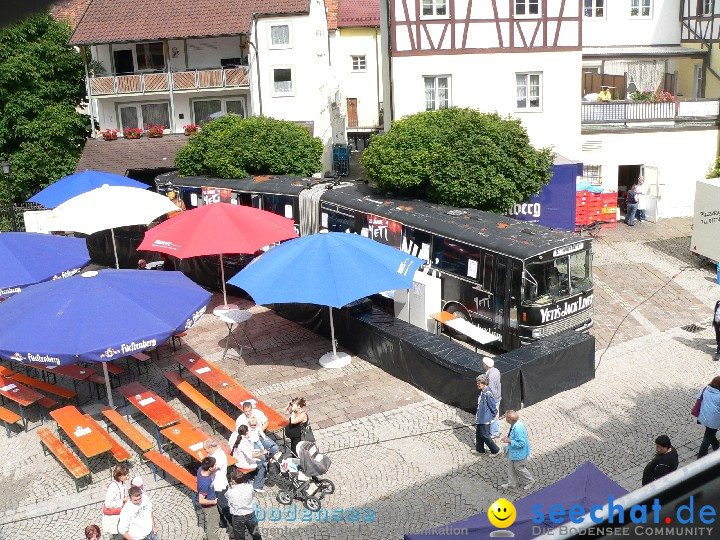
[228,233,424,367]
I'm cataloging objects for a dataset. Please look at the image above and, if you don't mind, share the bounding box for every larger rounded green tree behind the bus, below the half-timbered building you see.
[362,107,554,213]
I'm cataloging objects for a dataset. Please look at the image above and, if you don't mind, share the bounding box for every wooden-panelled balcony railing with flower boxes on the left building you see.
[90,66,250,97]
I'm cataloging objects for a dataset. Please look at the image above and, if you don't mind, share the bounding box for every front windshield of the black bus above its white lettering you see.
[524,250,592,304]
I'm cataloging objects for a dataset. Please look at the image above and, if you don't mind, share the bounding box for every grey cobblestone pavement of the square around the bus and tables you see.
[0,219,720,540]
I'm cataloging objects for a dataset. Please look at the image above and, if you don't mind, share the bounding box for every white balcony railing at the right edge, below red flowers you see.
[581,99,720,125]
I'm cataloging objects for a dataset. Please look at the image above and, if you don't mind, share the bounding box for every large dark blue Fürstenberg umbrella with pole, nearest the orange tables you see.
[0,270,210,405]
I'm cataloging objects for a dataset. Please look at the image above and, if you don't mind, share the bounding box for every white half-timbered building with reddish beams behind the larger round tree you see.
[382,0,582,155]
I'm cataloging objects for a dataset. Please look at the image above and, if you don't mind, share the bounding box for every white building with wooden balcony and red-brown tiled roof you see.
[70,0,336,166]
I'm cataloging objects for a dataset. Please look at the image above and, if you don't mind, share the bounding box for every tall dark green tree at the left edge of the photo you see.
[0,14,90,205]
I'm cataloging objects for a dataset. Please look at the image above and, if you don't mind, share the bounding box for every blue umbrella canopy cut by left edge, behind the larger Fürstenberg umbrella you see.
[0,233,90,298]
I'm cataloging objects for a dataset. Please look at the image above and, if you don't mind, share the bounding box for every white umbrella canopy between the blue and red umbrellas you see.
[48,185,177,234]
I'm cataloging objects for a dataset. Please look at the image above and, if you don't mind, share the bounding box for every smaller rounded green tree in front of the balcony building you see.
[175,114,323,178]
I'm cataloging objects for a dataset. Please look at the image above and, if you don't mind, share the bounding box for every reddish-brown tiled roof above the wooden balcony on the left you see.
[70,0,310,45]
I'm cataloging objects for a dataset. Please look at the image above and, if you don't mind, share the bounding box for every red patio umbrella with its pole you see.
[138,203,297,307]
